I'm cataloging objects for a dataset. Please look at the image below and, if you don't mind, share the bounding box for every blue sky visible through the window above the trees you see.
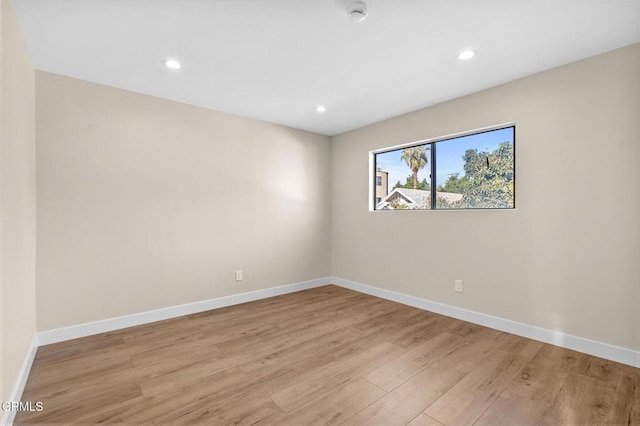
[376,127,514,192]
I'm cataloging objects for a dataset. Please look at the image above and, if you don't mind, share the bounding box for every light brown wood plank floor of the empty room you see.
[15,286,640,425]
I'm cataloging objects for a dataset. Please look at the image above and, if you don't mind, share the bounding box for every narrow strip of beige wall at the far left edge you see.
[0,0,36,401]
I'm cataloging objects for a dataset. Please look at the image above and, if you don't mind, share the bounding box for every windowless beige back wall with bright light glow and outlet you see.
[36,72,331,330]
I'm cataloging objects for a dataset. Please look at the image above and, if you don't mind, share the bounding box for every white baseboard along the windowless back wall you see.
[38,277,331,345]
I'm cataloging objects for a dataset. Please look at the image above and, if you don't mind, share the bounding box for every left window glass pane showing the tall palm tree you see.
[375,144,431,210]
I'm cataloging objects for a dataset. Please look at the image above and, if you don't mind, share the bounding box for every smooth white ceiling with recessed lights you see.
[14,0,640,135]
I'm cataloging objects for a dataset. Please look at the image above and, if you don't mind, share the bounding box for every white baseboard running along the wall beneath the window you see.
[331,277,640,368]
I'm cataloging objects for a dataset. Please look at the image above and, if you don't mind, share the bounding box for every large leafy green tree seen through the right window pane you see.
[460,142,514,208]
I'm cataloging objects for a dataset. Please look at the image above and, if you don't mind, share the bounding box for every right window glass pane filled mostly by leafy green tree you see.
[435,127,514,209]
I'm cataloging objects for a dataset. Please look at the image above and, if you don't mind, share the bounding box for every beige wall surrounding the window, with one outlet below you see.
[332,44,640,350]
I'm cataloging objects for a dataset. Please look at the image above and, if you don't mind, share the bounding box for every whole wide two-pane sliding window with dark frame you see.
[370,125,515,210]
